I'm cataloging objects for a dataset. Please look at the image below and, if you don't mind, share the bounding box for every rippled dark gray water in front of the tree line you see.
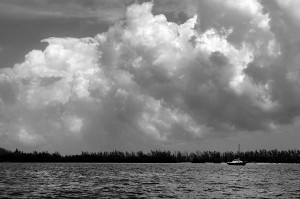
[0,163,300,198]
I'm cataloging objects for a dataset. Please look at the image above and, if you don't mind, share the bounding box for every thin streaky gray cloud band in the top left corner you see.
[0,0,126,22]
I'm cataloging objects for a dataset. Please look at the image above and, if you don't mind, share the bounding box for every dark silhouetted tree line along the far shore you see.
[0,148,300,163]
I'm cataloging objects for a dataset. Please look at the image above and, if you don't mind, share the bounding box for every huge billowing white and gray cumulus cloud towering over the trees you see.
[0,0,300,151]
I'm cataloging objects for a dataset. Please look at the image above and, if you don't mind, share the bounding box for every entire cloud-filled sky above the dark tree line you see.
[0,0,300,154]
